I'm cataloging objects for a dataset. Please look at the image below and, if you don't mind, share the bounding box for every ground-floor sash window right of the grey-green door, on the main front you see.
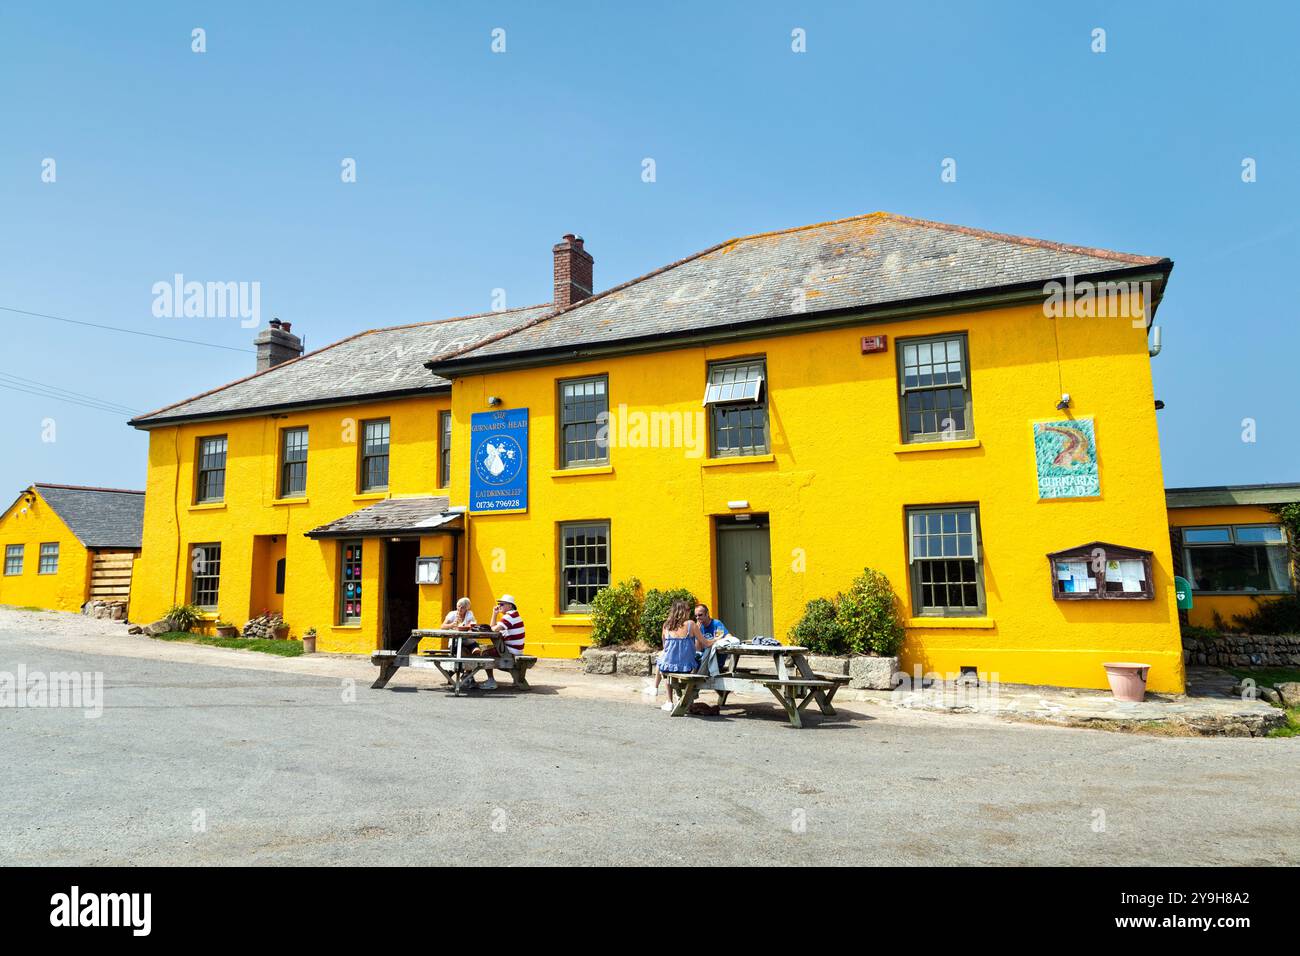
[907,505,984,617]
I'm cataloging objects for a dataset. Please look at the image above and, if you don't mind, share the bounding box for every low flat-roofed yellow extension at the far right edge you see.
[1165,484,1300,627]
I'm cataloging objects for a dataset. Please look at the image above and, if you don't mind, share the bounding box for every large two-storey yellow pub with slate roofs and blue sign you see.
[133,213,1183,691]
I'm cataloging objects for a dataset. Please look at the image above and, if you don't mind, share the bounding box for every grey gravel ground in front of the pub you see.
[0,610,1300,865]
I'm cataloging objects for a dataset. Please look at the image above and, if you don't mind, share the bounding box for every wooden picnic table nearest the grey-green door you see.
[664,644,848,727]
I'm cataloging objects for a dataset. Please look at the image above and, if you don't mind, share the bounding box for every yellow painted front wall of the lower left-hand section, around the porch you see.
[131,397,455,653]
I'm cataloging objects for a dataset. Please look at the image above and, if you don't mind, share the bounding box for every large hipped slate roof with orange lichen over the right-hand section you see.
[429,212,1173,372]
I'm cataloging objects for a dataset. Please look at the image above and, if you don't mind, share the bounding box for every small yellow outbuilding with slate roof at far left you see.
[0,484,144,611]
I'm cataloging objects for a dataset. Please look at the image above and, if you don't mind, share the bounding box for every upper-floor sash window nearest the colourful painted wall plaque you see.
[898,333,975,442]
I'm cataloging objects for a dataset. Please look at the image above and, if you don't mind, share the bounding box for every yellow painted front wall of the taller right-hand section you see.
[451,299,1183,691]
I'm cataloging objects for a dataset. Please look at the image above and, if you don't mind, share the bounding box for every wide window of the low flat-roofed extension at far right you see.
[1183,524,1292,592]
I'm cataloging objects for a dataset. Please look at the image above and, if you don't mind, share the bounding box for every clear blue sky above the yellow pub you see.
[0,0,1300,493]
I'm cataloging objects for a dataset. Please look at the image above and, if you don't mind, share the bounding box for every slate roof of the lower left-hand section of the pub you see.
[130,304,551,428]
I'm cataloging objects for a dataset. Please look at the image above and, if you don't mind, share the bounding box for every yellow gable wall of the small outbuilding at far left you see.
[0,489,94,611]
